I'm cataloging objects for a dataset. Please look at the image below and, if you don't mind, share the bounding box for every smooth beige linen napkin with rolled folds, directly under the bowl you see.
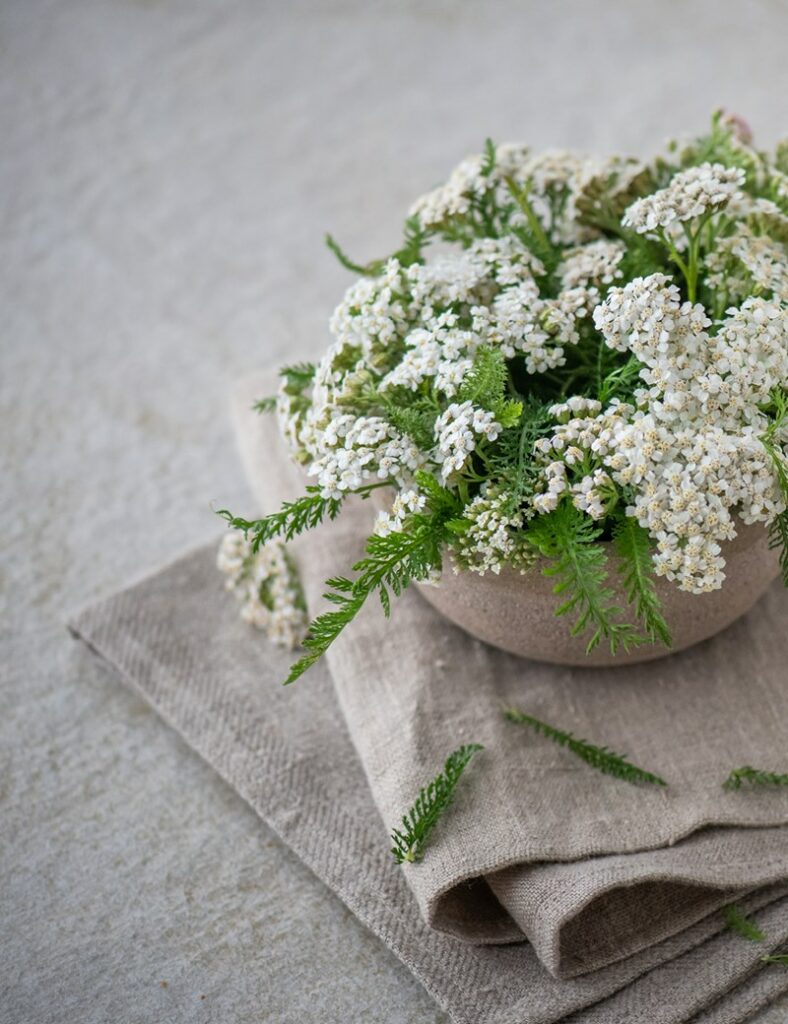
[234,375,788,977]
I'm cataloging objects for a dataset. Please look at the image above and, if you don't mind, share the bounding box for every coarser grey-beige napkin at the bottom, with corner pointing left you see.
[72,544,788,1024]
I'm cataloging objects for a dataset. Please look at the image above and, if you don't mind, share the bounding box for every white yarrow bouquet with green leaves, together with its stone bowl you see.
[225,114,788,680]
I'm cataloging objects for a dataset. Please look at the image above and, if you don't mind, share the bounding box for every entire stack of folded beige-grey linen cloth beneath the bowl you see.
[74,370,788,1024]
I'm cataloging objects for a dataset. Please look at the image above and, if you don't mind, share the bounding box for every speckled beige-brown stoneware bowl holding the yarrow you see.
[411,523,780,666]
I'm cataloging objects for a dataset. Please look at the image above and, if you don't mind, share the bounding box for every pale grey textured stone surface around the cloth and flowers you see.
[0,0,788,1024]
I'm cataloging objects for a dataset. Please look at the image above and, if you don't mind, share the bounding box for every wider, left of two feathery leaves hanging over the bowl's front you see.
[521,501,645,654]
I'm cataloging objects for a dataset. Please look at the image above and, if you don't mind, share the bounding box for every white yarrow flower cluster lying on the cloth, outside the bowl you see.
[216,531,309,650]
